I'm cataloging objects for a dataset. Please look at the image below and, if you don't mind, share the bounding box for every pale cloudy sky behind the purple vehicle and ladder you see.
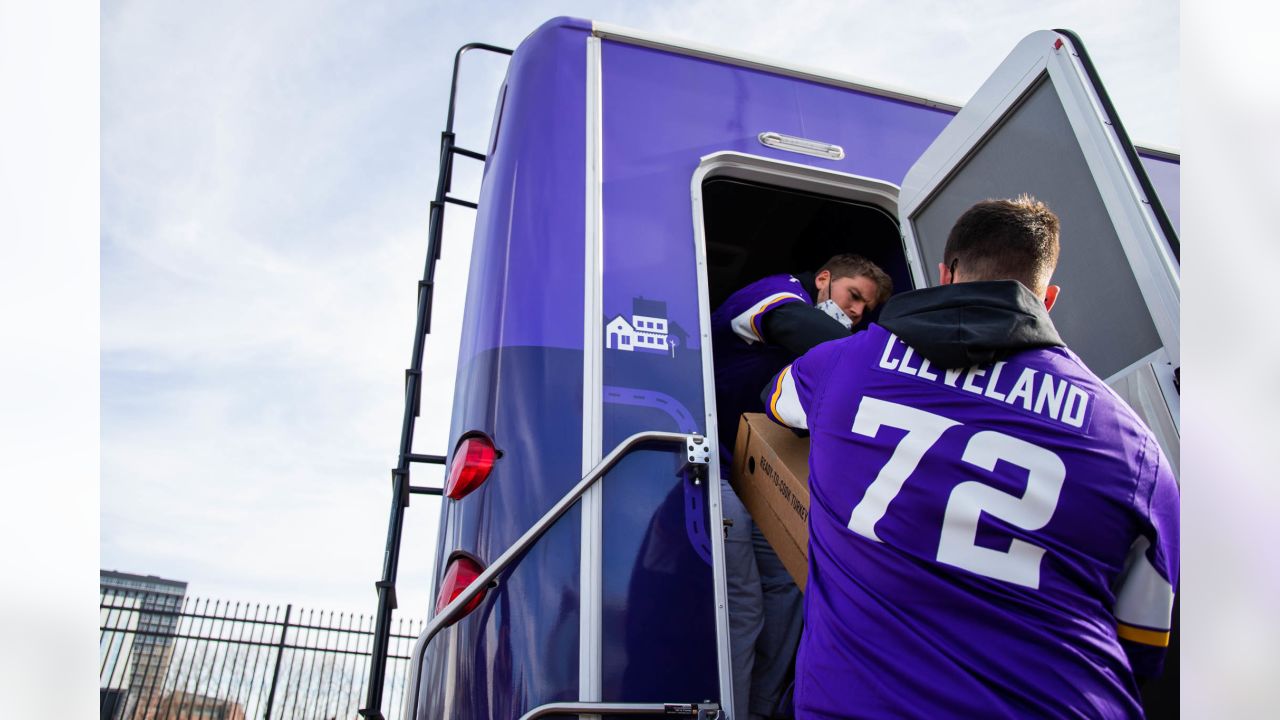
[101,0,1180,612]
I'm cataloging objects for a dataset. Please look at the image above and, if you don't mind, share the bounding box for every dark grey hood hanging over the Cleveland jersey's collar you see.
[879,281,1065,369]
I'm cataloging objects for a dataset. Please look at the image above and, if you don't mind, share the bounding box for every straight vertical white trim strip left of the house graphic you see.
[577,32,604,719]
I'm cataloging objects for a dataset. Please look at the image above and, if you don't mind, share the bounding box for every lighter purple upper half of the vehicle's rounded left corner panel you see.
[458,18,591,364]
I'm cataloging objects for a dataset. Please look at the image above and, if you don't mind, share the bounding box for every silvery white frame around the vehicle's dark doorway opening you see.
[690,151,901,717]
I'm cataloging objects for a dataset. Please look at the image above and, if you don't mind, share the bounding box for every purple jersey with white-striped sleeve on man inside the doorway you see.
[712,275,813,453]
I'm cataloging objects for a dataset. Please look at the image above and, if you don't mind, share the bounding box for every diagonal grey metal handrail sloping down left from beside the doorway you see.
[404,430,710,720]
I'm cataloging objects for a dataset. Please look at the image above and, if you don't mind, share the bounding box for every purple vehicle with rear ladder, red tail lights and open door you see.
[362,18,1180,720]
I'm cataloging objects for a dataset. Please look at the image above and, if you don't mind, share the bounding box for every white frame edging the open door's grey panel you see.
[899,31,1181,433]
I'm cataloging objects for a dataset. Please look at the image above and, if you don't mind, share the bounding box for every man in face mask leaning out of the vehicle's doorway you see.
[712,255,893,719]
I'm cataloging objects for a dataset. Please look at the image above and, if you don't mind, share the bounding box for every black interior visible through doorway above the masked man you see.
[703,177,913,319]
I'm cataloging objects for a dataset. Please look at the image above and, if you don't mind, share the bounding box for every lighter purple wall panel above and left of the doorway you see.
[602,41,952,347]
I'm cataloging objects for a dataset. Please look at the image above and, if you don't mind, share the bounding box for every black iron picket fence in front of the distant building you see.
[99,592,422,720]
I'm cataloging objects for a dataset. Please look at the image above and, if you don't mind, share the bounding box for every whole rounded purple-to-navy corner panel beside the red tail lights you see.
[417,18,590,720]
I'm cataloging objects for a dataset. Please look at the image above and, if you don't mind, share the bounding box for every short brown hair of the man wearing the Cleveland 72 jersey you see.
[942,195,1059,293]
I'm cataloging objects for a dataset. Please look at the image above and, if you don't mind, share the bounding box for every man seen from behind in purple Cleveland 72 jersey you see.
[765,196,1179,719]
